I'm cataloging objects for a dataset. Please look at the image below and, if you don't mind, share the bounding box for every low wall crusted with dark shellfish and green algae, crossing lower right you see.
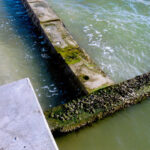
[45,73,150,133]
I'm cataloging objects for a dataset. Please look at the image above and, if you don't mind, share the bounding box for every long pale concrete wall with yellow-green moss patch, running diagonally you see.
[22,0,113,94]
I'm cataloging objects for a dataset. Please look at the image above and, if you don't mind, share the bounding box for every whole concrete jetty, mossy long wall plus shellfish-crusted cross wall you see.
[19,0,150,133]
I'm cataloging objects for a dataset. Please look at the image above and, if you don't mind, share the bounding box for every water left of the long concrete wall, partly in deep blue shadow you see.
[0,0,72,109]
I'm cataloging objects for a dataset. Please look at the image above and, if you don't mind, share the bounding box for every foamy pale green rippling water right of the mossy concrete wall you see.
[47,0,150,82]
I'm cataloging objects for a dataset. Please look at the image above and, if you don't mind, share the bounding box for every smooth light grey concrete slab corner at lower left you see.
[0,79,58,150]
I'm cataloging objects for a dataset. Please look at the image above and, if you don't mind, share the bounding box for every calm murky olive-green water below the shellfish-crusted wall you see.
[56,100,150,150]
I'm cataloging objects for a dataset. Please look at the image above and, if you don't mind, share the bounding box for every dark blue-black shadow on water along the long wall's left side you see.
[2,0,81,109]
